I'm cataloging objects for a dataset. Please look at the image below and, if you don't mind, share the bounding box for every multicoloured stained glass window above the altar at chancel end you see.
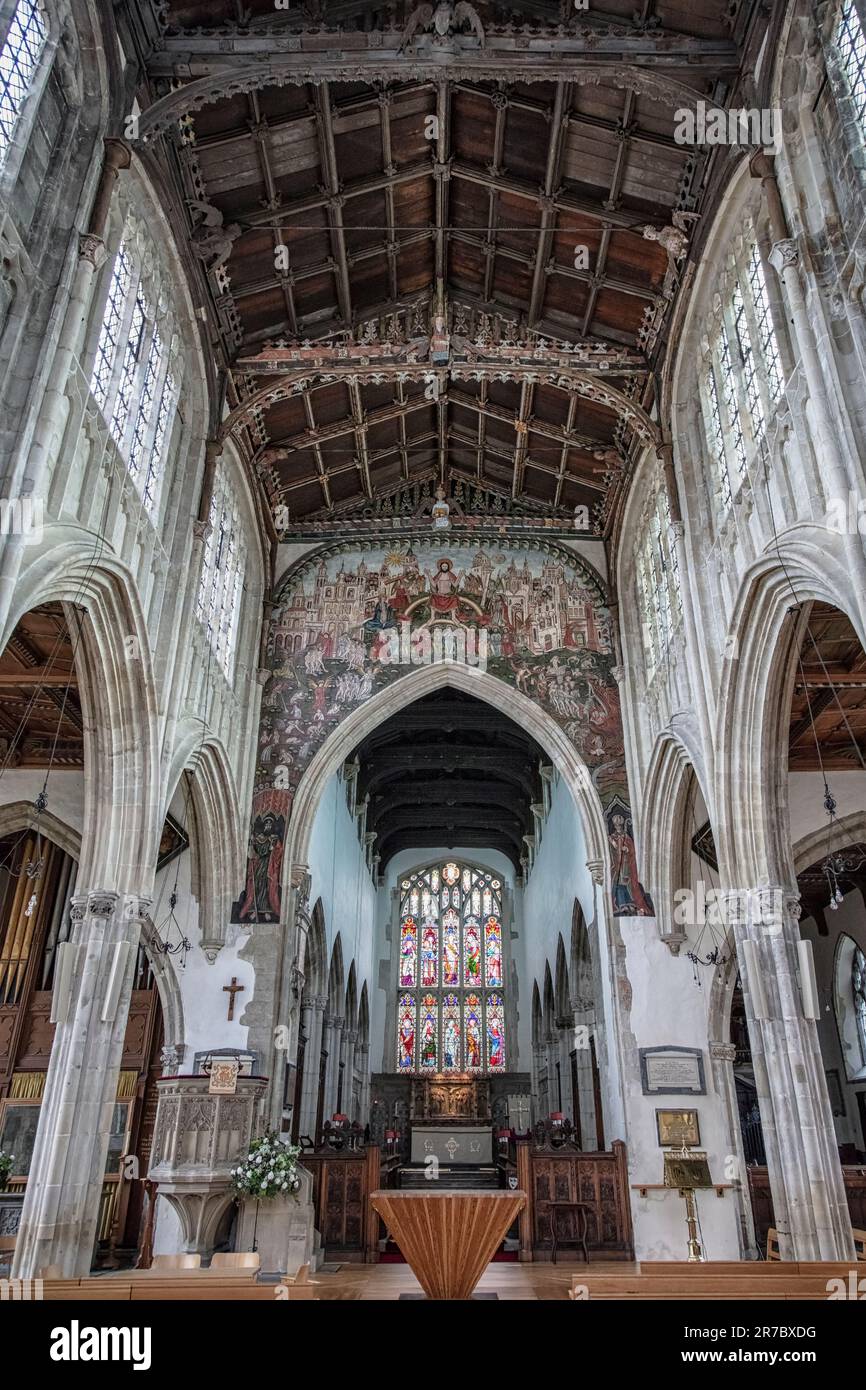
[396,862,506,1073]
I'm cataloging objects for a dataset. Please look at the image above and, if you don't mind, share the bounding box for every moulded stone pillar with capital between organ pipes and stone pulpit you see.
[14,891,150,1279]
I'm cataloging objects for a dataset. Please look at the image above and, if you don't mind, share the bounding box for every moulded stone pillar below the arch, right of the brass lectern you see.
[727,887,853,1259]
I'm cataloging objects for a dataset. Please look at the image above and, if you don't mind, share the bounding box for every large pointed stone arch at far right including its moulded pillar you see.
[714,550,865,1259]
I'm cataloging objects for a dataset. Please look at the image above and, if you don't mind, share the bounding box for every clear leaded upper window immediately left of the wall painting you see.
[196,468,243,678]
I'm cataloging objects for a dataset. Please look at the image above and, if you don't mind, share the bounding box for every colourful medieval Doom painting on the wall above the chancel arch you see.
[234,537,652,923]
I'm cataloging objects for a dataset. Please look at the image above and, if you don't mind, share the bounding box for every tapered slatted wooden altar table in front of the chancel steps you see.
[370,1184,527,1298]
